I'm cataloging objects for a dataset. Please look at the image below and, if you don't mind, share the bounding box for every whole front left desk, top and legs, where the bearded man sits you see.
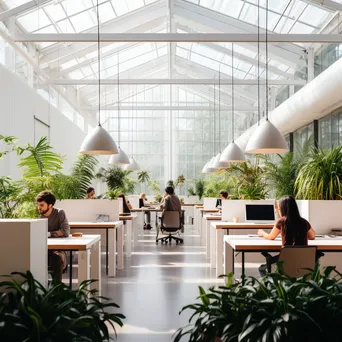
[47,235,101,295]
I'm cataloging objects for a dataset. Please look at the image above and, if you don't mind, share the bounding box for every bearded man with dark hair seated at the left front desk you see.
[36,190,70,283]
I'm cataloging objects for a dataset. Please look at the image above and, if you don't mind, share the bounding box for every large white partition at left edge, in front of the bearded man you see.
[0,219,48,286]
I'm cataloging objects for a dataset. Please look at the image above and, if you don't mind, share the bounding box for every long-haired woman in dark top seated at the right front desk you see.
[258,196,321,277]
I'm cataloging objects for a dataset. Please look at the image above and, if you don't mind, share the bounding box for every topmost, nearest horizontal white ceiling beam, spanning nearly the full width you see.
[15,33,342,43]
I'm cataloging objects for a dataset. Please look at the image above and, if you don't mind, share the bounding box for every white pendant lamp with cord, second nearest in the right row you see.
[220,43,246,163]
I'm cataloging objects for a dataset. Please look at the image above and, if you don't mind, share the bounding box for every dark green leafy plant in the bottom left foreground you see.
[0,272,125,342]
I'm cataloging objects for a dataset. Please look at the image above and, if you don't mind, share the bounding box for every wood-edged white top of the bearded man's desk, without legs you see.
[48,235,101,251]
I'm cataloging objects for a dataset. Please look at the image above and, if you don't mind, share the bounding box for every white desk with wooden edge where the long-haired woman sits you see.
[224,235,342,277]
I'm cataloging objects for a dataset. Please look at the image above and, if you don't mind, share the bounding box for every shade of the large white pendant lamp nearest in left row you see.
[80,125,119,155]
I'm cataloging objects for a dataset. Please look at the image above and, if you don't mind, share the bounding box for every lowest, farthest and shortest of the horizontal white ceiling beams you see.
[81,105,257,111]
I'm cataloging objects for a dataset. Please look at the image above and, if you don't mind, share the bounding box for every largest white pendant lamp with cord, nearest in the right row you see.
[246,0,289,154]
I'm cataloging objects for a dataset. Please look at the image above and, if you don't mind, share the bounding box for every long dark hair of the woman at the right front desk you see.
[279,196,307,244]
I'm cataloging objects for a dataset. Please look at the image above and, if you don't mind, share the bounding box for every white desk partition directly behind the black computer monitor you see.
[222,199,274,222]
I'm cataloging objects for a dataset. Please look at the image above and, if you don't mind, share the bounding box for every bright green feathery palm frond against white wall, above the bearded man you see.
[19,137,63,177]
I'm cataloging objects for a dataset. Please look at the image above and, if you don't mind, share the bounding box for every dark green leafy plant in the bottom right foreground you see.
[174,266,342,342]
